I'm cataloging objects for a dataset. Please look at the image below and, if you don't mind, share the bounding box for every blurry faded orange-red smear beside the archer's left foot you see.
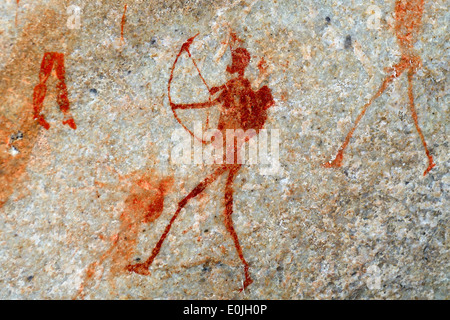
[75,174,173,299]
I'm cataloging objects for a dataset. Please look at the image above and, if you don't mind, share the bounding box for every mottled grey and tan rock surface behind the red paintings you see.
[0,0,450,299]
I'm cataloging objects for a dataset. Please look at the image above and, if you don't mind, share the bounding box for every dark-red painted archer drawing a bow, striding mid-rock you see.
[127,36,274,291]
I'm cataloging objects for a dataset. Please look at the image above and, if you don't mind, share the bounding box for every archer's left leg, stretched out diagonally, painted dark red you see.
[126,166,227,275]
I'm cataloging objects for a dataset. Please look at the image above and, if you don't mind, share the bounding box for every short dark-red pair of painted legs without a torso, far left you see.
[33,52,77,130]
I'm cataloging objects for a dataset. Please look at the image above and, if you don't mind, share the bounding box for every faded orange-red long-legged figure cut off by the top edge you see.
[323,0,435,176]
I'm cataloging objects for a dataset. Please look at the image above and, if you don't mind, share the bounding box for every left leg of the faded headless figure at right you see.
[323,59,409,168]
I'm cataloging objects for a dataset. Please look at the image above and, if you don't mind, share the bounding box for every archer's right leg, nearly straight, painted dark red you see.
[224,165,253,291]
